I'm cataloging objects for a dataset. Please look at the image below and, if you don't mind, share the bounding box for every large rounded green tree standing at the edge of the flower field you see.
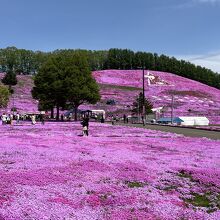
[32,50,100,120]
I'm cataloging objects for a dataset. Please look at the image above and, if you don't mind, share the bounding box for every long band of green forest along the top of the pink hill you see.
[0,47,220,89]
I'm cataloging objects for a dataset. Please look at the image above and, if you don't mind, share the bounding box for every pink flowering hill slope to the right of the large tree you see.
[93,70,220,124]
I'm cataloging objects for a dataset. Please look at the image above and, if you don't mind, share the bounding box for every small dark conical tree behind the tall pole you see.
[132,92,153,115]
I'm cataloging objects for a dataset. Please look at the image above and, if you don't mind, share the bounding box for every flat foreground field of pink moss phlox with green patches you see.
[0,122,220,220]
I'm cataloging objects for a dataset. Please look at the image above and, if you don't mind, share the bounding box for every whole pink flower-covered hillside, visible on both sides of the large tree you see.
[1,70,220,124]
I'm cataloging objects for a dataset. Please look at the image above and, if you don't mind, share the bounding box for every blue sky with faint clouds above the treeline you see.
[0,0,220,72]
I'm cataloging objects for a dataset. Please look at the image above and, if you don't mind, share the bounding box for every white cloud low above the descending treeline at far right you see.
[175,52,220,73]
